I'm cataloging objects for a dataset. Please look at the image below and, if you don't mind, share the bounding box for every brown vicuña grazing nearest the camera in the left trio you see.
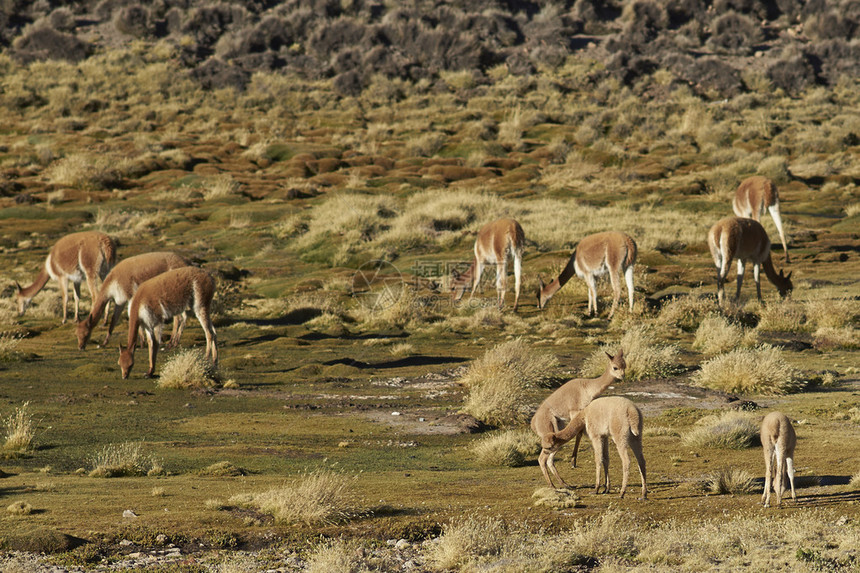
[119,267,218,379]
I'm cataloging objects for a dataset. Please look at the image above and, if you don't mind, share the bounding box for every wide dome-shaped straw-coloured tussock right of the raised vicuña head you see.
[692,344,804,395]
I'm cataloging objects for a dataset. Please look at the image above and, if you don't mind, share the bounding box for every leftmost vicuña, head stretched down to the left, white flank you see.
[15,231,116,324]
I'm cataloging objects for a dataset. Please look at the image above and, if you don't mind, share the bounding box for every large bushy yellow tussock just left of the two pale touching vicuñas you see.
[460,338,558,426]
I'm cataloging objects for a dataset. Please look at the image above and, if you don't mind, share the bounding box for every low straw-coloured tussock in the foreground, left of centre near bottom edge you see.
[229,470,351,525]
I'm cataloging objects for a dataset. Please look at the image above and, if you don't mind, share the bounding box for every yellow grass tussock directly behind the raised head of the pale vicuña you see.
[580,324,679,381]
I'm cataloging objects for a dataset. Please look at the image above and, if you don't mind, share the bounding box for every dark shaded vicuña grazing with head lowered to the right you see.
[708,217,794,304]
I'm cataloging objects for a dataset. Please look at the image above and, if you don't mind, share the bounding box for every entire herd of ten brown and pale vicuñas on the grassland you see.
[15,176,808,506]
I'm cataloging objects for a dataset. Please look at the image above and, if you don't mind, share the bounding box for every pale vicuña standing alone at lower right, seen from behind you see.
[761,412,797,507]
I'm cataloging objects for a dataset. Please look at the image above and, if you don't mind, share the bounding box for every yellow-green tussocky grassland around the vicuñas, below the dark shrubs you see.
[0,7,860,571]
